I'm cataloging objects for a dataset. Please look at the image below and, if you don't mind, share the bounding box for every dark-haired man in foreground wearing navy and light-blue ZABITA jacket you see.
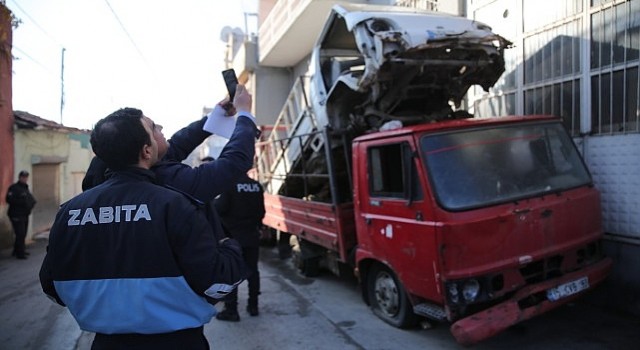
[40,97,255,349]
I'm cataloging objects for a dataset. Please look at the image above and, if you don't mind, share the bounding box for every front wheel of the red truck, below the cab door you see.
[367,264,418,328]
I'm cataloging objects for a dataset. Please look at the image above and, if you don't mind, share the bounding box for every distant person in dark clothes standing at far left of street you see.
[5,170,36,259]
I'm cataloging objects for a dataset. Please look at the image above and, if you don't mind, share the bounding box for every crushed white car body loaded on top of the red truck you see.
[314,4,511,129]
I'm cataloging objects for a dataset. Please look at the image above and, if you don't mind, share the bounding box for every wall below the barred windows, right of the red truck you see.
[578,134,640,315]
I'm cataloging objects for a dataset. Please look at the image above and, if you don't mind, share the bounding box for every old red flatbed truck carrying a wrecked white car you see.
[258,6,612,345]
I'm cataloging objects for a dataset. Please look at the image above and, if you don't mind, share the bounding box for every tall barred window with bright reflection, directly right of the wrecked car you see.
[523,0,583,135]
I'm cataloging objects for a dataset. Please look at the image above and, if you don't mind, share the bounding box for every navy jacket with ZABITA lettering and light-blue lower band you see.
[40,168,242,334]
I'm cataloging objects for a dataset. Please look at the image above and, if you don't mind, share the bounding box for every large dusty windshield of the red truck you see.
[421,122,591,211]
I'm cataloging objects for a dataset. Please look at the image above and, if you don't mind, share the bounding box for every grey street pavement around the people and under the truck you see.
[0,236,640,350]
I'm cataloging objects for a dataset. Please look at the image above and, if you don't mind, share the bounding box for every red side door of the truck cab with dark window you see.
[356,136,438,299]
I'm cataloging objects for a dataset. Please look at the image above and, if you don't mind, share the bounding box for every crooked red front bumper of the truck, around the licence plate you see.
[451,258,613,345]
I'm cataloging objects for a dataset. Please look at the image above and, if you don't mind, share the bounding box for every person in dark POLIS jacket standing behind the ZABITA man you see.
[215,174,265,322]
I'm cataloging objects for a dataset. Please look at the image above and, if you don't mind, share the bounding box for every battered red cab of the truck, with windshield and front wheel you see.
[353,116,611,344]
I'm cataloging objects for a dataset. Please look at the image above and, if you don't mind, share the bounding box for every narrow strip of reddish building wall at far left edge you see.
[0,3,15,248]
